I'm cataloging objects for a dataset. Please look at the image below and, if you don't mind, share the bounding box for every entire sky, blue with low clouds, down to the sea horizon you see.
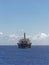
[0,0,49,45]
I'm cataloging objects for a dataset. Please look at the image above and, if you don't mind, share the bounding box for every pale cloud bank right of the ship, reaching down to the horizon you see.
[31,33,49,45]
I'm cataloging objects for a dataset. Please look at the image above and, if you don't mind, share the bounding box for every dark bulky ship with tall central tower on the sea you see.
[17,33,32,48]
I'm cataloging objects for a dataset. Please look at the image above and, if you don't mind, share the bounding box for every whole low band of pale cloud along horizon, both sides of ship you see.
[0,32,49,45]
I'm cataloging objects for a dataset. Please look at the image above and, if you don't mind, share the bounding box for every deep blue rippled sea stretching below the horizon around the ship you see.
[0,46,49,65]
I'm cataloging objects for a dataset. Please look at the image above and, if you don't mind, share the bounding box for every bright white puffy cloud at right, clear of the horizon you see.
[32,33,49,41]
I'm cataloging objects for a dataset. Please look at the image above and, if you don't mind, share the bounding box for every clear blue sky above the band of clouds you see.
[0,0,49,43]
